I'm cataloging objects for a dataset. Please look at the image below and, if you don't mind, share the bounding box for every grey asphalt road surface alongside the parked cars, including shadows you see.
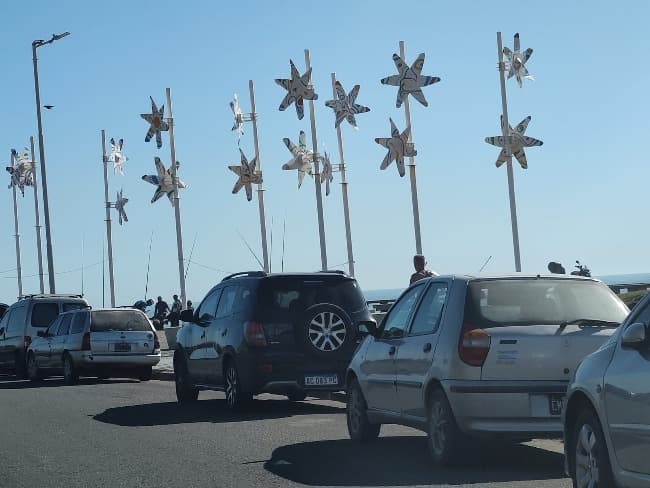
[0,376,570,488]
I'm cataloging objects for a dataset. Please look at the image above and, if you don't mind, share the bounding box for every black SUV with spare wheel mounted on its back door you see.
[174,272,372,410]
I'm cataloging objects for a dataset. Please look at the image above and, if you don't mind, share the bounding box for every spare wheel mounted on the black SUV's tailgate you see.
[298,303,356,359]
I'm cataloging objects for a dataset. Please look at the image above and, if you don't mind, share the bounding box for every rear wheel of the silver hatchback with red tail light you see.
[427,389,464,465]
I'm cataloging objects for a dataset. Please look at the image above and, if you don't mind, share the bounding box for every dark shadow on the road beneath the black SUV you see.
[93,399,345,427]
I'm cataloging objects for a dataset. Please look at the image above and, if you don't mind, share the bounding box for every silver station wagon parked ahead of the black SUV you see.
[27,308,160,384]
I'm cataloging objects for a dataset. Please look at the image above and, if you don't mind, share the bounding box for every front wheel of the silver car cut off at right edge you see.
[569,409,615,487]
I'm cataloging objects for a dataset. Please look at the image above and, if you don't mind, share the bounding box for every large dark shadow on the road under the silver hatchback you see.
[264,436,565,486]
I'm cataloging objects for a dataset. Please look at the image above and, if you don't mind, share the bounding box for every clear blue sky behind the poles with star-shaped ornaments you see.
[0,1,650,306]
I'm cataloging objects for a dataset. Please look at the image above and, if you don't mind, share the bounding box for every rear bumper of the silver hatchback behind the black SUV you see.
[442,381,568,437]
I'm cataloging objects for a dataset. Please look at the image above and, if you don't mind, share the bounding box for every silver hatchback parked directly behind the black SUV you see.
[346,275,628,464]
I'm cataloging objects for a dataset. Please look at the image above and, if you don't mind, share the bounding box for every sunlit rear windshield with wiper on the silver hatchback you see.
[465,279,628,328]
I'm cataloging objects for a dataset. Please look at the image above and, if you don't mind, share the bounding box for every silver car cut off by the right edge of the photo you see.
[564,296,650,487]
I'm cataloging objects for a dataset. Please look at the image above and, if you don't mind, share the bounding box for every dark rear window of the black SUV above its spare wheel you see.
[259,276,366,320]
